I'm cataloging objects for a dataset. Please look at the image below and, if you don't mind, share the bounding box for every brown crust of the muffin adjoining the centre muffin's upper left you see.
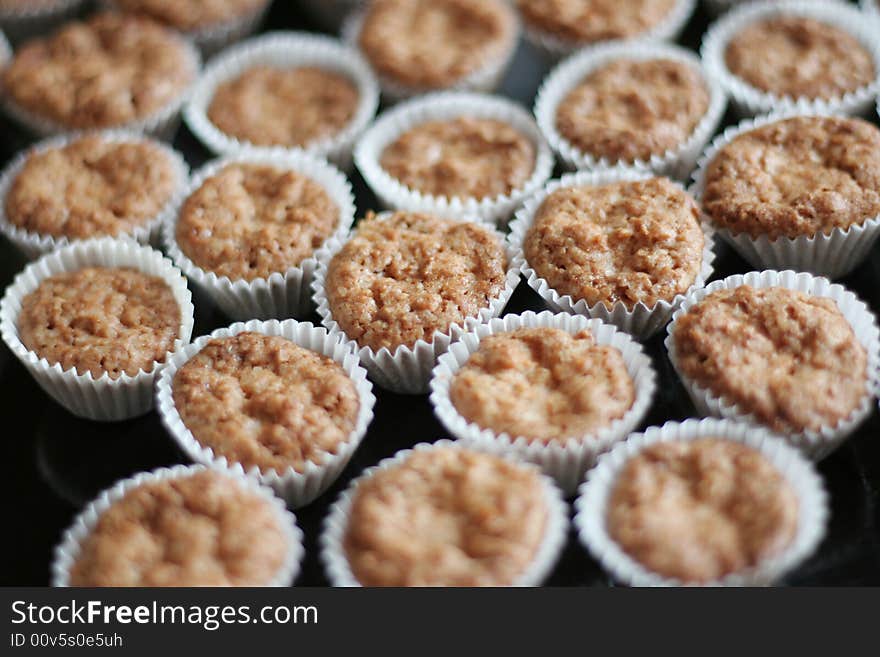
[175,163,339,281]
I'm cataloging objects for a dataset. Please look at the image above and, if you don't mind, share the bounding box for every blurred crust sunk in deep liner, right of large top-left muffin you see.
[208,65,360,146]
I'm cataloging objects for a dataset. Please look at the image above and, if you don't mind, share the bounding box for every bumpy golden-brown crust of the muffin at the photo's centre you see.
[324,212,507,353]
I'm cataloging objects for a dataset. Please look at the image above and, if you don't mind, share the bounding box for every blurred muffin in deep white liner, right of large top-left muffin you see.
[184,32,379,170]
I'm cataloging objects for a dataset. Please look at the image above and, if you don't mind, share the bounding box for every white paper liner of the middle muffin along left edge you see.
[0,130,189,259]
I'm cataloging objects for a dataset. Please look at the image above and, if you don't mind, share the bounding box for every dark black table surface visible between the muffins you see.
[0,0,880,586]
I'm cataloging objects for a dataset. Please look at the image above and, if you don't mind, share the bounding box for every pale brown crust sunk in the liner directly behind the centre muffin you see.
[379,116,535,199]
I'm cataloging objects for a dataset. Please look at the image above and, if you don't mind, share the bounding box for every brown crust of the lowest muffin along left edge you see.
[16,267,180,379]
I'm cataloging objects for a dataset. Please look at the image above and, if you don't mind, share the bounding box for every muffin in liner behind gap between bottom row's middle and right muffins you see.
[430,311,656,495]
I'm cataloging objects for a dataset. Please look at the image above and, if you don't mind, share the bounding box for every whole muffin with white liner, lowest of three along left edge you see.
[0,237,193,422]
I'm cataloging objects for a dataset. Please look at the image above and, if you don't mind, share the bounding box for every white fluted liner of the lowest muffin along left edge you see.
[0,237,194,421]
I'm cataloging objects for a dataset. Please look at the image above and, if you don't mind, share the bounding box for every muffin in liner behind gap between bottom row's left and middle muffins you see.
[156,319,376,508]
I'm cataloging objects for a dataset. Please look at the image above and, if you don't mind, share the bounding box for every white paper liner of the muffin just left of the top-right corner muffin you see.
[535,41,727,179]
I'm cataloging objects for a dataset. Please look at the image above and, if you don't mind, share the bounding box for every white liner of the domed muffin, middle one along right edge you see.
[690,112,880,278]
